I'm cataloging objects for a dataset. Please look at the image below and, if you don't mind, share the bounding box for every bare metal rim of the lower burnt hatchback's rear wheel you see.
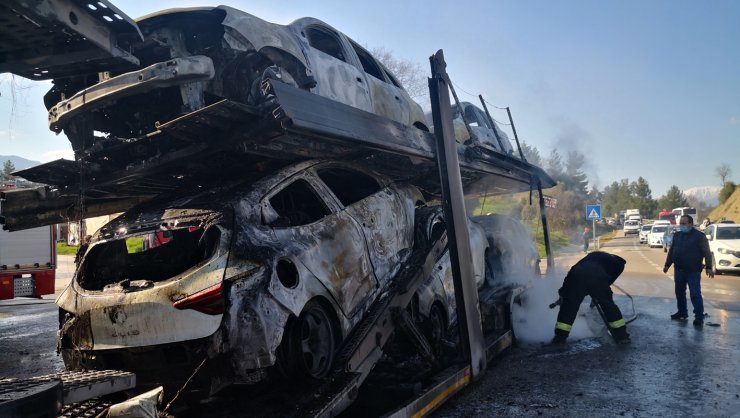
[297,305,336,378]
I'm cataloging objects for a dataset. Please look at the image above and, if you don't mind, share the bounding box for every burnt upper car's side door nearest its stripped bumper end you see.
[301,23,373,112]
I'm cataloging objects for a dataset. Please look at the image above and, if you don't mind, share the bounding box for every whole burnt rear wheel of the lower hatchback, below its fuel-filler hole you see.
[280,302,338,379]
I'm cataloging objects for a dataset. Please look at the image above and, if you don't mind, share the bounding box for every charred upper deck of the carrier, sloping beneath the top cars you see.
[0,82,555,230]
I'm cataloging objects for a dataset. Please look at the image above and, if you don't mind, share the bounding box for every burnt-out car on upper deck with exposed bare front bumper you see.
[45,6,428,151]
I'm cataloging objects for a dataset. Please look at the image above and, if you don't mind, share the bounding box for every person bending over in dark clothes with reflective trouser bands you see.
[552,251,630,344]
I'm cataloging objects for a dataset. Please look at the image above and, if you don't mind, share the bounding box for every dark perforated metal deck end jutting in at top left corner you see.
[0,0,143,80]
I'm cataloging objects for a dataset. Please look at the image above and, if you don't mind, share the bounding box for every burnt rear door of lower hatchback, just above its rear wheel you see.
[261,173,377,317]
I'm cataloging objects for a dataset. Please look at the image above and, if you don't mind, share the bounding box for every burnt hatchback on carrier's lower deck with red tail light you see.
[57,160,485,390]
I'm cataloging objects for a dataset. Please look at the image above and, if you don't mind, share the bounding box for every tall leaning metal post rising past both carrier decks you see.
[429,50,486,379]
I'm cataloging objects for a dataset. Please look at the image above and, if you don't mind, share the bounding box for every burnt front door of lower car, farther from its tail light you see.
[316,166,415,282]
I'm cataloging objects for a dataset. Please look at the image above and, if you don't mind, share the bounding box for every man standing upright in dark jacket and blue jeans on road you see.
[663,215,714,326]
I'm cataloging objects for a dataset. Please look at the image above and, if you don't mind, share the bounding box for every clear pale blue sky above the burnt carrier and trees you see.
[0,0,740,198]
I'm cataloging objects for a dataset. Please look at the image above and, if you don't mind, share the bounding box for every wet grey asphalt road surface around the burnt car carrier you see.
[0,242,740,418]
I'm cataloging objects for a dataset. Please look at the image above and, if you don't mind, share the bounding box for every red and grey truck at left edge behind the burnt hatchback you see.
[0,183,57,300]
